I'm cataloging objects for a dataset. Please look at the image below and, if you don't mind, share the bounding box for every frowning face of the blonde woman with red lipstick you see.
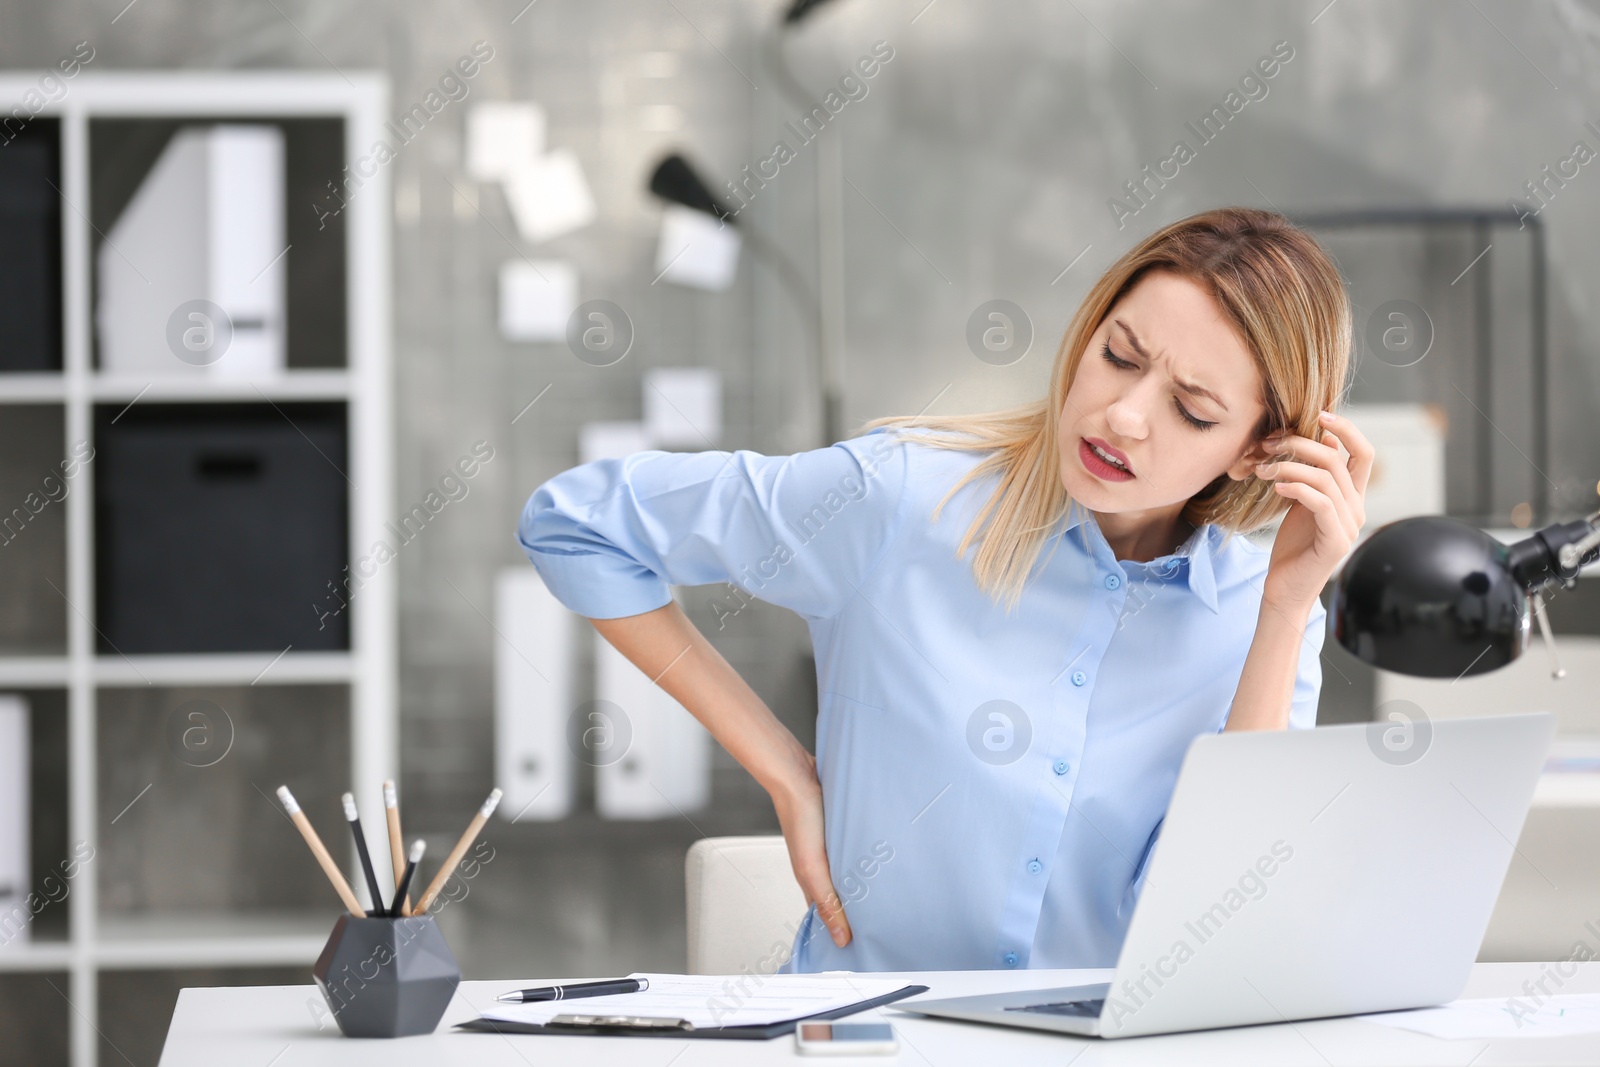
[1058,270,1266,514]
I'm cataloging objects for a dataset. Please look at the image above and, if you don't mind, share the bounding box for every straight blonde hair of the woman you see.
[864,208,1352,611]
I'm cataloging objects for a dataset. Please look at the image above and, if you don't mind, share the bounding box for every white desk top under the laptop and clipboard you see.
[162,963,1600,1067]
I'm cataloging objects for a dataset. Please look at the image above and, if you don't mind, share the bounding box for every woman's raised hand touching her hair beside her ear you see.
[1256,411,1374,609]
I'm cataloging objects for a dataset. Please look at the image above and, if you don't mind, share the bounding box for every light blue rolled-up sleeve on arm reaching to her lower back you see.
[517,427,907,619]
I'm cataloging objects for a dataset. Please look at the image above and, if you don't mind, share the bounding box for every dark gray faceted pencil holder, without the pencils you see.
[312,915,461,1037]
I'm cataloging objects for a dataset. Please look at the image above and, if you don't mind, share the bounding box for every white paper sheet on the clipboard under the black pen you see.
[483,974,906,1029]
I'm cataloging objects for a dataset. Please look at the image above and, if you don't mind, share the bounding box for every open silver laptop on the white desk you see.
[894,713,1555,1038]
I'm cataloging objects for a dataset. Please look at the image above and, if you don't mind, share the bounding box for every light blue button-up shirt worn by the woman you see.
[517,427,1326,971]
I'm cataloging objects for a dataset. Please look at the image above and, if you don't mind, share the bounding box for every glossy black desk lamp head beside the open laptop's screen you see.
[1330,512,1600,678]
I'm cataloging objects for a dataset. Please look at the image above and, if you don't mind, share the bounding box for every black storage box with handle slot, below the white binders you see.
[94,403,350,654]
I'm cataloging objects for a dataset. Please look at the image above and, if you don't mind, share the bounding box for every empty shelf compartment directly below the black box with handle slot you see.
[93,683,355,921]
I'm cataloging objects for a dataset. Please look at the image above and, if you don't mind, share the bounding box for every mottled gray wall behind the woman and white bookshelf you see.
[9,0,1600,977]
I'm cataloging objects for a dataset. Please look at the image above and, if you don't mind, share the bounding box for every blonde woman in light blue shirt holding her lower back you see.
[518,208,1373,971]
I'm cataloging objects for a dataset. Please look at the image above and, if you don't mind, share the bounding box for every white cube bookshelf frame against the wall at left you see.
[0,70,398,1067]
